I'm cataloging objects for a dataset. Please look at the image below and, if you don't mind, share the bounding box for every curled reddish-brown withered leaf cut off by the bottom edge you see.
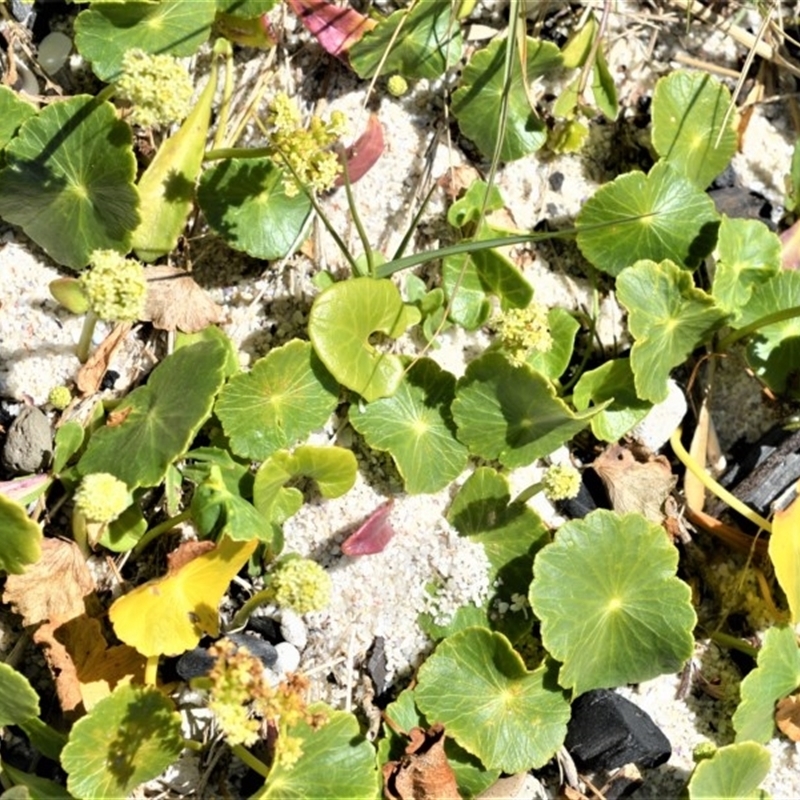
[383,723,461,800]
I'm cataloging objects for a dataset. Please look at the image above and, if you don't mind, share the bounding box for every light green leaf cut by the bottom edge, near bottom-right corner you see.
[688,742,770,800]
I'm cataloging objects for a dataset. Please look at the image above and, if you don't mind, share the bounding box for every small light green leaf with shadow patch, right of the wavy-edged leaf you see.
[711,215,781,325]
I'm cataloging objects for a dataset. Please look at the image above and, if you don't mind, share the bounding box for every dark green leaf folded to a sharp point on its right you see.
[452,353,599,468]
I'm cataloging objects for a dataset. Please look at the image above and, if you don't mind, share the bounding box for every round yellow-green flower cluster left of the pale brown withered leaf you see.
[79,250,147,322]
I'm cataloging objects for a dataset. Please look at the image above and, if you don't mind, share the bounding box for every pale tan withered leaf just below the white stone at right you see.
[592,444,677,523]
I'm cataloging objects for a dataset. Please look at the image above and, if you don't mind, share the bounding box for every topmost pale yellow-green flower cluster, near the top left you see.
[116,48,193,127]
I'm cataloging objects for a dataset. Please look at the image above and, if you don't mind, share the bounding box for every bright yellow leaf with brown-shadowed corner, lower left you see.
[108,536,258,658]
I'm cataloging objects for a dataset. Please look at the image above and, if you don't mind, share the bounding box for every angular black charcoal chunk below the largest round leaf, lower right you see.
[564,689,672,772]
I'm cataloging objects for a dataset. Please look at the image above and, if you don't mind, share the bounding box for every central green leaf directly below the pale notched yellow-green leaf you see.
[349,358,467,494]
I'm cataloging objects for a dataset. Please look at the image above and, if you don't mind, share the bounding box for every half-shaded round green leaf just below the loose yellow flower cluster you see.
[197,158,311,260]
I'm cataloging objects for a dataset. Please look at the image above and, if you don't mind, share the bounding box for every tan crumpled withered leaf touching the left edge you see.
[3,539,95,626]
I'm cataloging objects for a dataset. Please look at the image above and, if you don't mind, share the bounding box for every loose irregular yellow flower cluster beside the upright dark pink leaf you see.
[267,92,347,197]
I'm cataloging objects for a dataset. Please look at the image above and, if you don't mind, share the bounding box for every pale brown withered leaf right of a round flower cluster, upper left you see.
[142,265,222,333]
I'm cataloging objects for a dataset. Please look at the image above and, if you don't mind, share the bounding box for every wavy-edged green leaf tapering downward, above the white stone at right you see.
[617,261,728,403]
